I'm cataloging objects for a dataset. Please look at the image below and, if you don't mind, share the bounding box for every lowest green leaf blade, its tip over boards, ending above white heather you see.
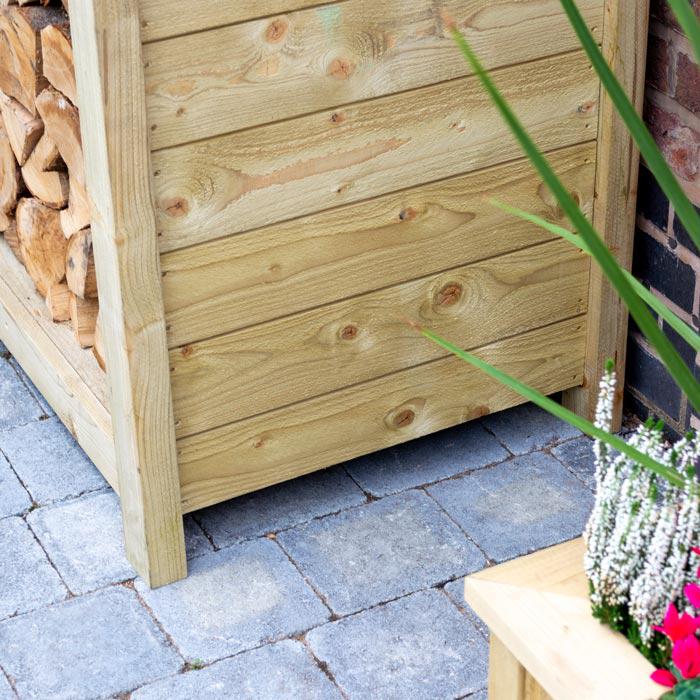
[418,327,685,488]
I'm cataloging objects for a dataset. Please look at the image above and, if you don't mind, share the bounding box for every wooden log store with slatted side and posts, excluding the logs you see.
[0,0,647,586]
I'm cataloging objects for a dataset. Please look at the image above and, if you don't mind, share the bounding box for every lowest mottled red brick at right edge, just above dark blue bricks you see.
[644,101,700,181]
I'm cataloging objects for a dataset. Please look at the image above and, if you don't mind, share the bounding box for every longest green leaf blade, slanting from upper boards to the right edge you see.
[451,23,700,412]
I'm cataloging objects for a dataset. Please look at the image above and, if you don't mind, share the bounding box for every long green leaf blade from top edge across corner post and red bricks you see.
[561,0,700,258]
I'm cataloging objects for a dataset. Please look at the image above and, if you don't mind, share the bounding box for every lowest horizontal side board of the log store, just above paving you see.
[178,317,586,511]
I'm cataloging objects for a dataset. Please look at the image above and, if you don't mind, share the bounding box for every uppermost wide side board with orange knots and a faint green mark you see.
[144,0,603,149]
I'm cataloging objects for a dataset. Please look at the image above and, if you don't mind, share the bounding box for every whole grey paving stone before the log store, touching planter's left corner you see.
[278,491,484,615]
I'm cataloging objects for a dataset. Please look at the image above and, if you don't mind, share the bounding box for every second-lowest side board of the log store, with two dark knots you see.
[170,240,590,437]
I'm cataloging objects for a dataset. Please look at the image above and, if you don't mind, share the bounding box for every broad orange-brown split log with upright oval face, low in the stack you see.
[16,197,68,297]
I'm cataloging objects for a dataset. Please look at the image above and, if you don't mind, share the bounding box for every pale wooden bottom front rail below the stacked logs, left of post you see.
[0,240,119,492]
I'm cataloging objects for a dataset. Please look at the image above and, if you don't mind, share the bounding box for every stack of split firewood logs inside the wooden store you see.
[0,0,104,368]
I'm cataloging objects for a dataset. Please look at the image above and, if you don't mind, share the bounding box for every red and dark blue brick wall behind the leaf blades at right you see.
[626,0,700,433]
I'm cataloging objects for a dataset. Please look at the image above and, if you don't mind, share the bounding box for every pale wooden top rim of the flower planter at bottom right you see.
[465,539,661,700]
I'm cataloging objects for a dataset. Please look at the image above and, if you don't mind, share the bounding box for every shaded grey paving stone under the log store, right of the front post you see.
[195,468,366,547]
